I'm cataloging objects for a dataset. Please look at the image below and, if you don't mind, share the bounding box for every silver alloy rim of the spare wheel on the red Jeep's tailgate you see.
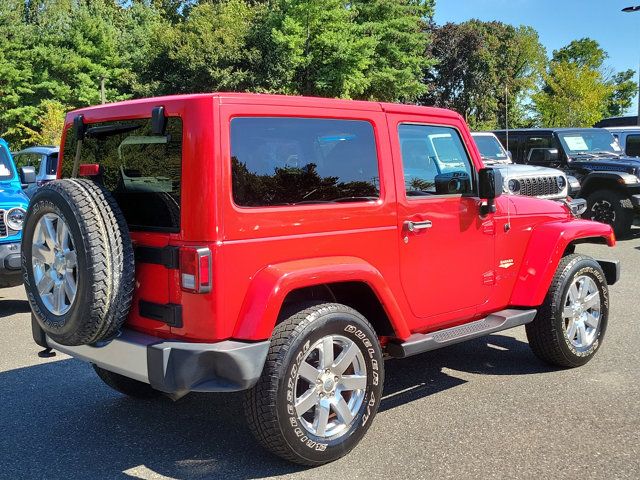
[31,213,78,315]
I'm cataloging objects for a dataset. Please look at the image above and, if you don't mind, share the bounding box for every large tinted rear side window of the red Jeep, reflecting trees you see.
[231,118,380,207]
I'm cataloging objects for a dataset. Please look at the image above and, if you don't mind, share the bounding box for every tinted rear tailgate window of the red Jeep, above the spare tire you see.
[62,117,182,232]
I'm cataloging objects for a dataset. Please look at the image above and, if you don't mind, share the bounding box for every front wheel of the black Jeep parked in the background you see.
[583,190,634,238]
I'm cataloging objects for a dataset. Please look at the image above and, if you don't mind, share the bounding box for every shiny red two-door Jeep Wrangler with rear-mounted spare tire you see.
[22,94,619,465]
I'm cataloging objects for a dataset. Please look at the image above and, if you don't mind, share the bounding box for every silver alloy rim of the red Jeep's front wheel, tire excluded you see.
[562,275,600,349]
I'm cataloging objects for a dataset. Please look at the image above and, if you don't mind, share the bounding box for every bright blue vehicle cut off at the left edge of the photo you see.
[0,138,29,288]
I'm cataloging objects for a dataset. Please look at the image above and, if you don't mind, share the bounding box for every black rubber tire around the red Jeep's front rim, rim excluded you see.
[526,254,609,368]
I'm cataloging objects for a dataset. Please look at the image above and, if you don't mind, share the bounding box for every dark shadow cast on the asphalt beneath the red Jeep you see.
[0,335,546,479]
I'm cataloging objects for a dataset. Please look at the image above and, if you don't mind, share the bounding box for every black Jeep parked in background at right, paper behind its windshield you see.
[494,128,640,237]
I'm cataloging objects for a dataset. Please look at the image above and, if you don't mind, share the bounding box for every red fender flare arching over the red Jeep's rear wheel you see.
[233,256,410,340]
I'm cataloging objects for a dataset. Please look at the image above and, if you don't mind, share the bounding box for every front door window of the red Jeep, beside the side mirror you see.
[398,124,473,197]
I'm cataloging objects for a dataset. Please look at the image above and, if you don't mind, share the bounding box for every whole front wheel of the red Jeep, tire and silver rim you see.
[526,254,609,367]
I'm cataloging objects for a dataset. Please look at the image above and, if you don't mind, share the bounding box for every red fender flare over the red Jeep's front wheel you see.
[509,219,616,307]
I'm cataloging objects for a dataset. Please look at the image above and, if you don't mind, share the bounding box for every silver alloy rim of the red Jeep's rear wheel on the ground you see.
[294,335,367,438]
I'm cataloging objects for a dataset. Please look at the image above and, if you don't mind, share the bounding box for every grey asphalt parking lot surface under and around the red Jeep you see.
[0,234,640,480]
